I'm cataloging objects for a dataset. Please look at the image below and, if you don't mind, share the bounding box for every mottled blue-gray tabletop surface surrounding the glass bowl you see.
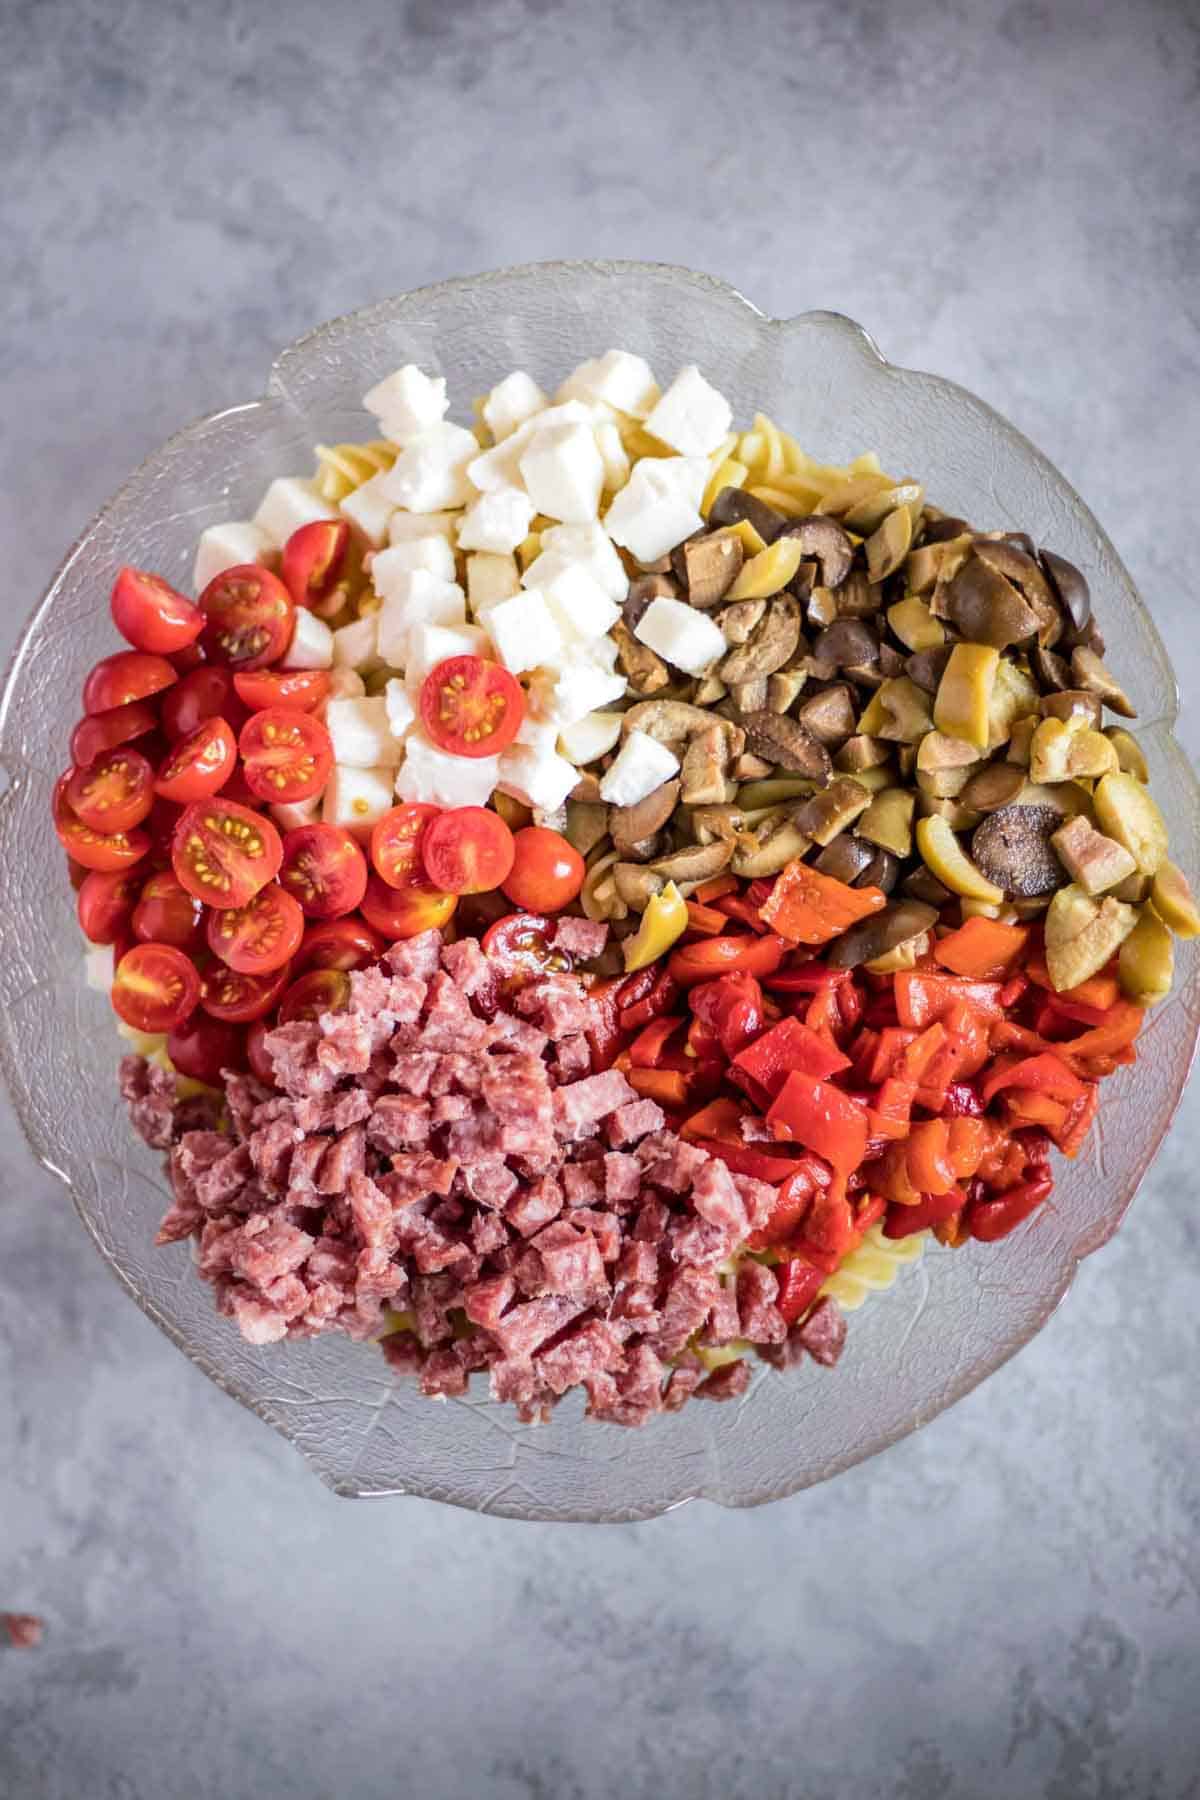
[0,0,1200,1800]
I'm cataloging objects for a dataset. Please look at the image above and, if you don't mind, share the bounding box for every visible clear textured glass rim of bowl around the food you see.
[0,263,1200,1521]
